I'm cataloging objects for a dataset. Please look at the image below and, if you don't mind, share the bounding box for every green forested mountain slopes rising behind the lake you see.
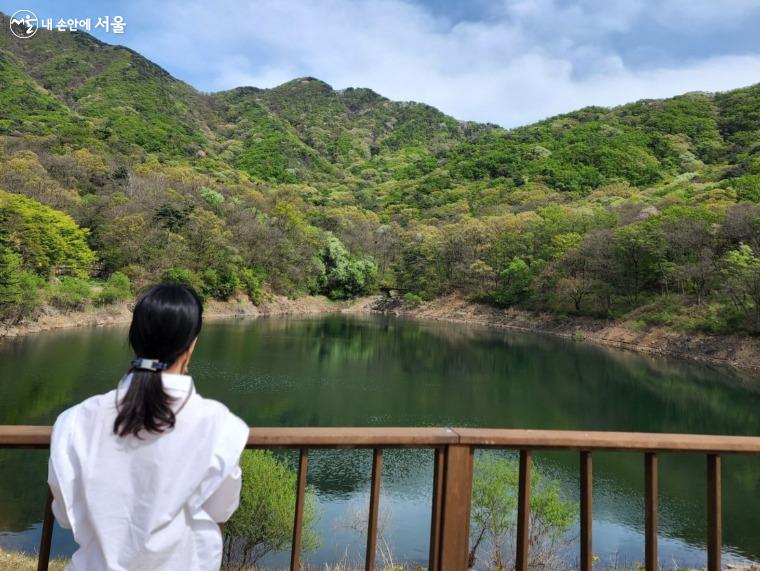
[0,16,760,333]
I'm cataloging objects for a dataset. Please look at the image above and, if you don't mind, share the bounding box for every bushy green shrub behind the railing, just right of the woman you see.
[224,450,319,565]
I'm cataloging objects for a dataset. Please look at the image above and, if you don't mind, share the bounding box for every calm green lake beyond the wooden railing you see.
[0,315,760,567]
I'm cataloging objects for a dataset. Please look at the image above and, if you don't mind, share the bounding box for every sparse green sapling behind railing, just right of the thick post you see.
[469,453,577,570]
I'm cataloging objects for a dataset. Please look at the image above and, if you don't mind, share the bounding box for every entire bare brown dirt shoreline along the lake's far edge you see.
[0,294,760,372]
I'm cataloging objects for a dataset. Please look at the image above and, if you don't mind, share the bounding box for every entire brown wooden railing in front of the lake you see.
[0,426,760,571]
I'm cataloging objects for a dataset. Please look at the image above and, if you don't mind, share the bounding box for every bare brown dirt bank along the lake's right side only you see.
[374,294,760,372]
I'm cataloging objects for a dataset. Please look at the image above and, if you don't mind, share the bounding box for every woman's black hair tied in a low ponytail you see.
[113,284,203,437]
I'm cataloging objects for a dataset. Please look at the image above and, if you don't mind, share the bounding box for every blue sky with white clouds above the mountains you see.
[0,0,760,127]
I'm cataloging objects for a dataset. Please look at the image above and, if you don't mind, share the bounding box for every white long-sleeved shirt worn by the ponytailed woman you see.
[48,373,248,571]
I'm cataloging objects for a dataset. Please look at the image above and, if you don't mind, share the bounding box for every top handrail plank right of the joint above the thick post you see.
[454,428,760,454]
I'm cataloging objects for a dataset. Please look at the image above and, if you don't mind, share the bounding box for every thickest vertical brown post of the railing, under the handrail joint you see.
[439,444,473,571]
